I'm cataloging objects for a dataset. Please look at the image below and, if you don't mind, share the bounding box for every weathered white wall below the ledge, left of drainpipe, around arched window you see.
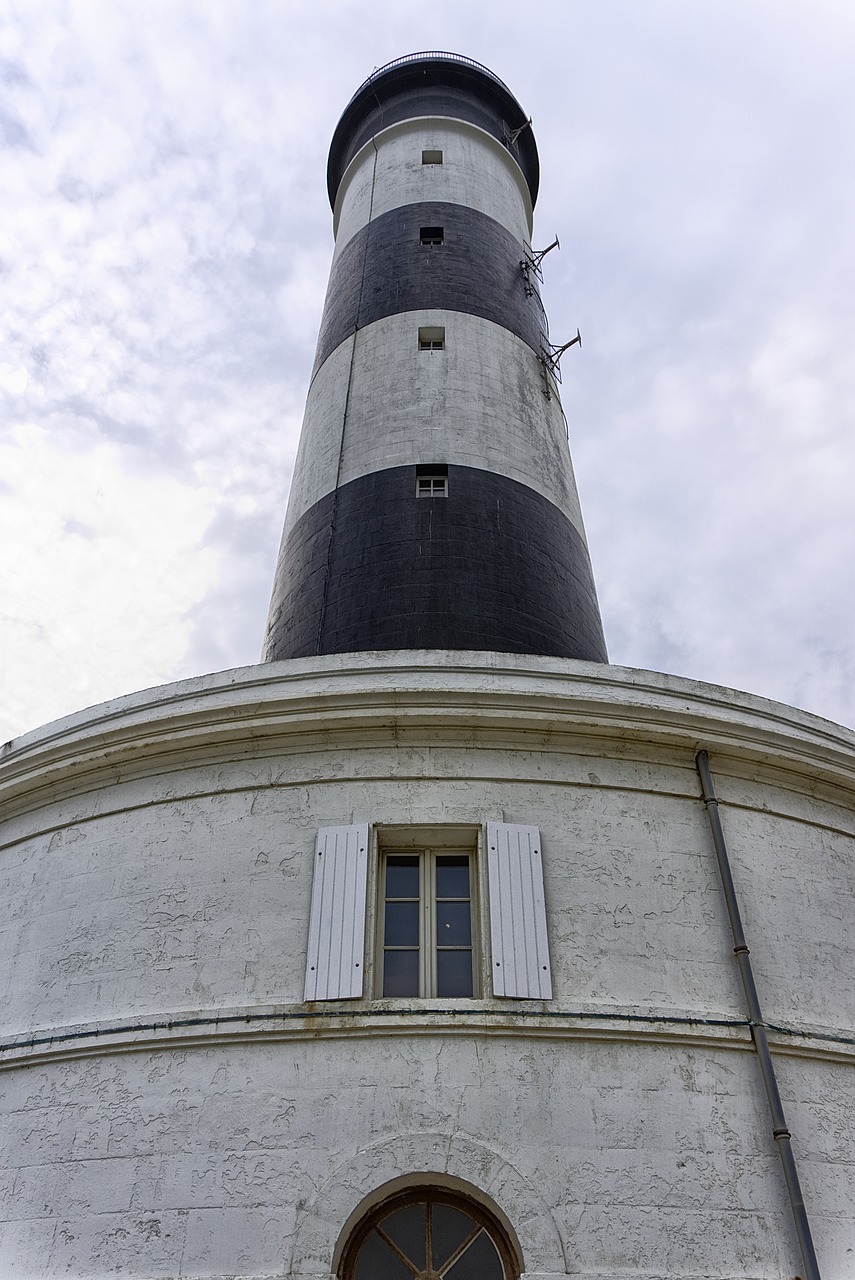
[0,1033,834,1276]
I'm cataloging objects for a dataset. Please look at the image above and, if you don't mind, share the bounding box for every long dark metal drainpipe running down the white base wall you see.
[695,751,820,1280]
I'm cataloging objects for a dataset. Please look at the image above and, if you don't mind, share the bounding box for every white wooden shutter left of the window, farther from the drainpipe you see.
[305,822,369,1000]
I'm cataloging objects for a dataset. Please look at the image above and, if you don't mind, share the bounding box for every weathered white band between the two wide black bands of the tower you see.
[285,310,584,536]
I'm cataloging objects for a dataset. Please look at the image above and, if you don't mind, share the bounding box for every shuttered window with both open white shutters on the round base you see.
[303,822,552,1001]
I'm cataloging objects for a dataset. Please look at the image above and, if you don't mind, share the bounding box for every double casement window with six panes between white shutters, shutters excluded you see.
[378,849,475,997]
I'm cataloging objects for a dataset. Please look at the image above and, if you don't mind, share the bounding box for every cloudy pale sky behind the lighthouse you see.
[0,0,855,741]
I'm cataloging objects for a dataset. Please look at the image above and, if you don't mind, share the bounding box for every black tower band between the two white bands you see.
[315,201,544,371]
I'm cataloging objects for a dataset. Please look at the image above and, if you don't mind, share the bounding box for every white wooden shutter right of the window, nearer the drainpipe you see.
[486,822,552,1000]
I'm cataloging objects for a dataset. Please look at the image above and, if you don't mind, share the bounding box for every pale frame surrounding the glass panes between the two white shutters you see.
[367,824,489,1001]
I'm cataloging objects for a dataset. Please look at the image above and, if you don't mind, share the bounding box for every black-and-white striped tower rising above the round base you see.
[264,52,607,662]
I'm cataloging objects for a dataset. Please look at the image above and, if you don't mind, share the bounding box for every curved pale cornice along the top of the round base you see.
[0,650,855,809]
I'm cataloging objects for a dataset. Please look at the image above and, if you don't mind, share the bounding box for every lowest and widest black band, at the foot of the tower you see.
[265,466,608,662]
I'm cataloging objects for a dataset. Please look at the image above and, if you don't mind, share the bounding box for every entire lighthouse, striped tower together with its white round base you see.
[0,54,855,1280]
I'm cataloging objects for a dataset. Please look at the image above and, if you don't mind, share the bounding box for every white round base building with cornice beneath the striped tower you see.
[0,652,855,1280]
